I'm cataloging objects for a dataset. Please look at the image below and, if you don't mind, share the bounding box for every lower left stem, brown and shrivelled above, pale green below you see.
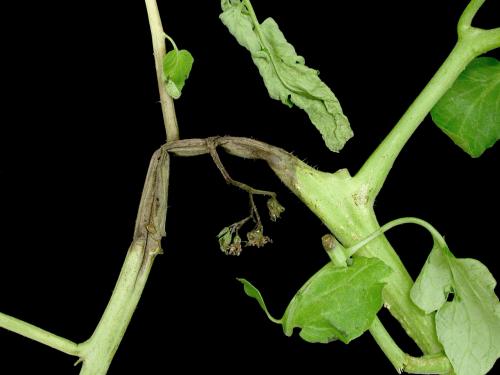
[79,149,169,375]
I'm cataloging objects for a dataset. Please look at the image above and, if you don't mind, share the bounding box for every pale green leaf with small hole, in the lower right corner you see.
[411,240,500,375]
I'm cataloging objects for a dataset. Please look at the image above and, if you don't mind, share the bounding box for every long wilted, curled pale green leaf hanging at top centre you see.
[220,0,353,152]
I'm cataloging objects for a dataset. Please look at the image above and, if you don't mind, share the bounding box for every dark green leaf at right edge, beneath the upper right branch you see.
[431,57,500,158]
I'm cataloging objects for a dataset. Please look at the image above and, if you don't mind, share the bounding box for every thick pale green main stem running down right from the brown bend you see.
[270,161,442,354]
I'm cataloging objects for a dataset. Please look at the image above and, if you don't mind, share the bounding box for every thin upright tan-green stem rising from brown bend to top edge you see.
[146,0,179,142]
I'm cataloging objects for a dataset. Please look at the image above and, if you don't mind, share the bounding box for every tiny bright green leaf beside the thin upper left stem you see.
[163,49,194,99]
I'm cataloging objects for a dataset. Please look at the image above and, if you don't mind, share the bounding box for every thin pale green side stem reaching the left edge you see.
[0,313,80,356]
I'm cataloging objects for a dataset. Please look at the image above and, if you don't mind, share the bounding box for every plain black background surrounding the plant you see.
[0,0,500,375]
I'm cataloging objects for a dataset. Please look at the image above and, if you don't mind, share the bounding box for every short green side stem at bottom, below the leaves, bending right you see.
[370,317,452,374]
